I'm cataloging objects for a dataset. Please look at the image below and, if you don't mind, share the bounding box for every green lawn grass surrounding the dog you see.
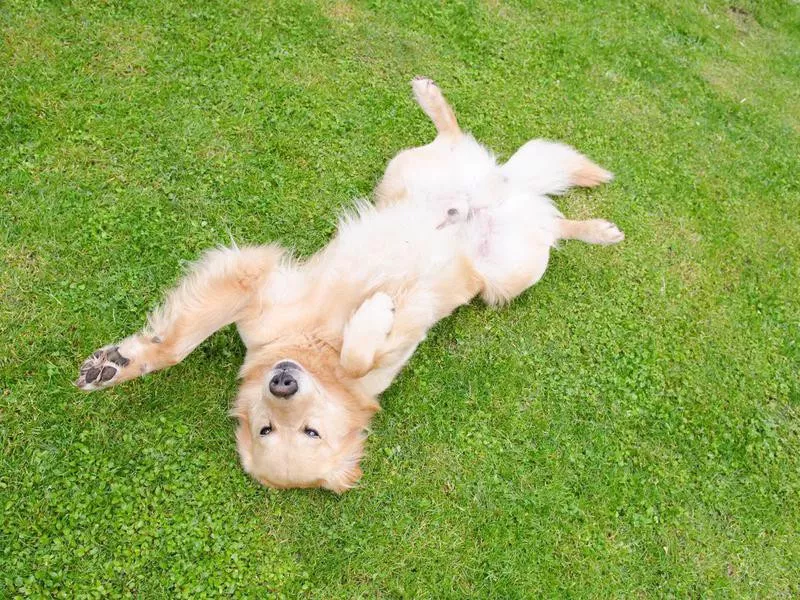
[0,0,800,598]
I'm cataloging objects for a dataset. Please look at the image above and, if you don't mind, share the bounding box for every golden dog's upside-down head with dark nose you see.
[234,356,378,492]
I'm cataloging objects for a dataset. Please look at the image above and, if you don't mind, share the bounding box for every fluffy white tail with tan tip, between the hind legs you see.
[500,140,614,195]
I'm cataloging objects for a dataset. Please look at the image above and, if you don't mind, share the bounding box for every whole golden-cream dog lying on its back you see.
[76,78,624,493]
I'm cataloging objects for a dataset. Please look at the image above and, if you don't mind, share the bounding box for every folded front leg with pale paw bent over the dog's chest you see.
[339,292,394,377]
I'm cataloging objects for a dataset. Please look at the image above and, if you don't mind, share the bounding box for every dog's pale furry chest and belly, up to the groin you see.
[238,205,479,348]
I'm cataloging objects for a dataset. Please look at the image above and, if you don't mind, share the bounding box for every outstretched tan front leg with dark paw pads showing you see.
[75,246,283,391]
